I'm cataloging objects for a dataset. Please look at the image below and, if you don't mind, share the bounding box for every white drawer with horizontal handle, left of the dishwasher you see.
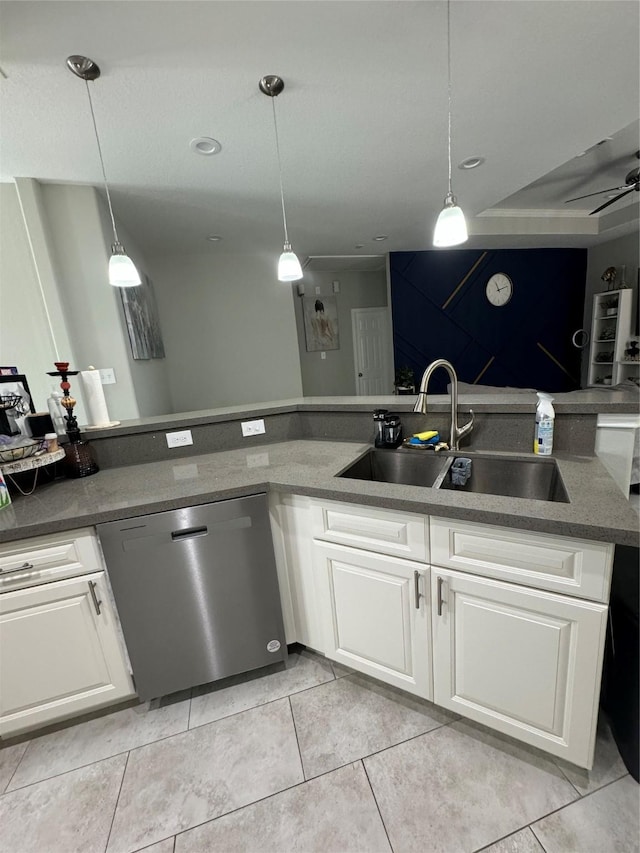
[0,529,103,592]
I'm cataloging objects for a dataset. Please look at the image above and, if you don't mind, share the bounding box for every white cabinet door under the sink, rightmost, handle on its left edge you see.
[431,567,607,767]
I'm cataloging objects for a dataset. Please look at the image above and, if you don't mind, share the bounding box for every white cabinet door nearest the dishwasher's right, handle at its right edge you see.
[314,541,432,699]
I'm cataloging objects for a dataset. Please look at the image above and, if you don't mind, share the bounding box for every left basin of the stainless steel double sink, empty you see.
[338,450,451,486]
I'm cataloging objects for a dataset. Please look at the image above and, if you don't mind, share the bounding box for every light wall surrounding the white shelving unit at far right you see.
[581,231,640,388]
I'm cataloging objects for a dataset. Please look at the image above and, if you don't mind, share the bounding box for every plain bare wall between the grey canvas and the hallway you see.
[150,252,302,412]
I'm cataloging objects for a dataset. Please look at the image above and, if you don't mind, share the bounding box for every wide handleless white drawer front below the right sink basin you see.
[430,518,613,601]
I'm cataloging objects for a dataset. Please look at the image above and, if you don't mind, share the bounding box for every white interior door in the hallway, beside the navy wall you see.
[351,308,393,396]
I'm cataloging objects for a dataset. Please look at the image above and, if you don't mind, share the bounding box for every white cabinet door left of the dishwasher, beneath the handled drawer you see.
[0,572,135,735]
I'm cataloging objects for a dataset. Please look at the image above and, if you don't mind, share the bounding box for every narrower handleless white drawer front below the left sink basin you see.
[311,501,429,562]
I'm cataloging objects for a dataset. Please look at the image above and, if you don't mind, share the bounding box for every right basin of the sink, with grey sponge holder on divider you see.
[440,453,569,503]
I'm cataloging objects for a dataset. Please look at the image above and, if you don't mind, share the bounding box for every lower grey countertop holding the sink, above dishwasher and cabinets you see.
[0,440,638,546]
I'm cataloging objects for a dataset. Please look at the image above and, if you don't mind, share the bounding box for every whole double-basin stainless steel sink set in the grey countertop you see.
[338,449,569,503]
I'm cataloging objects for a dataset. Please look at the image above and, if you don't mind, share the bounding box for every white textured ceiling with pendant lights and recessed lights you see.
[0,0,640,257]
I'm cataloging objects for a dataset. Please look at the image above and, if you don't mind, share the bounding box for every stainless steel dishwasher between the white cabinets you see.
[97,494,287,699]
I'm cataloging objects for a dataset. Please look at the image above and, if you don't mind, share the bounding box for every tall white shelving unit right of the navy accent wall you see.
[588,289,640,385]
